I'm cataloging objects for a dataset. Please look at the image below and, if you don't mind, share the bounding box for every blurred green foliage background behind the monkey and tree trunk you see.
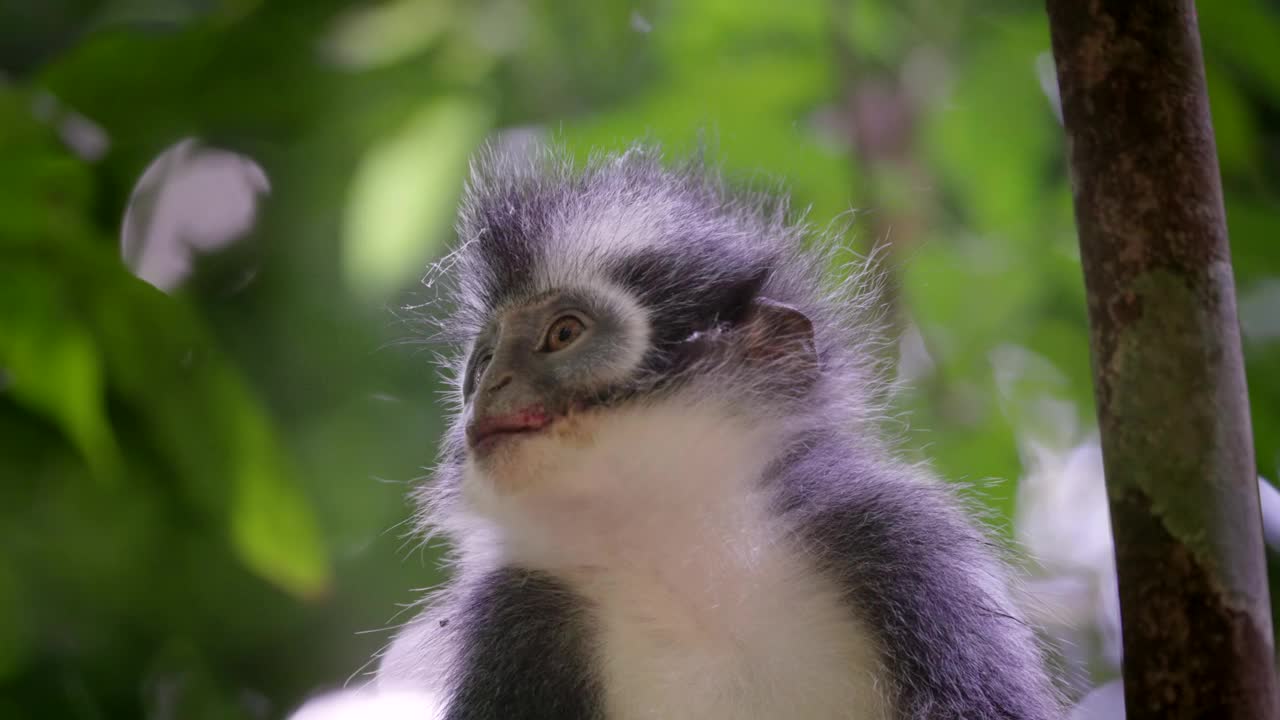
[0,0,1280,720]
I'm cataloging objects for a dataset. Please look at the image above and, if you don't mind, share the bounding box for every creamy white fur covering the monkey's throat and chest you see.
[455,404,887,720]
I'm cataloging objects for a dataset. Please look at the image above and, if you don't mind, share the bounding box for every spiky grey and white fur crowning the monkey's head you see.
[421,146,883,538]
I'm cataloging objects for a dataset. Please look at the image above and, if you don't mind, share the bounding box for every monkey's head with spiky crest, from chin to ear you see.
[445,147,820,491]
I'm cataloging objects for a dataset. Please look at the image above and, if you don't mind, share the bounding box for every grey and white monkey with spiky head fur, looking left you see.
[375,145,1062,720]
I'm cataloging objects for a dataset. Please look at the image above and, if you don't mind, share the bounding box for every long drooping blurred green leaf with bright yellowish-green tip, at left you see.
[85,275,329,596]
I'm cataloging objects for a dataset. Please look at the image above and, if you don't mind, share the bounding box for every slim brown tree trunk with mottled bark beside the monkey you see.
[1047,0,1280,720]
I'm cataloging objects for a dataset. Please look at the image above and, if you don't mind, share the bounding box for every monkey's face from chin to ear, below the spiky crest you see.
[462,269,817,492]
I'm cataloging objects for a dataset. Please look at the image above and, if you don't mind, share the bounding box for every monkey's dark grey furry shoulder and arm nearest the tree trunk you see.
[778,448,1061,720]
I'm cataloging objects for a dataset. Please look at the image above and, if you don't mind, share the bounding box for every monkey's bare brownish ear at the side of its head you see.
[740,297,819,387]
